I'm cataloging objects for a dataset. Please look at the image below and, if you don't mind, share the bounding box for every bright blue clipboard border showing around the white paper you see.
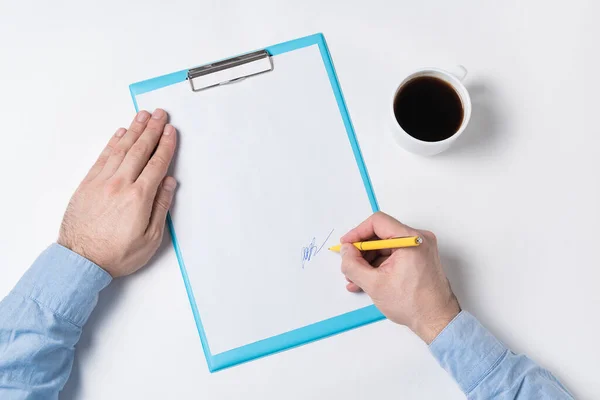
[129,33,385,372]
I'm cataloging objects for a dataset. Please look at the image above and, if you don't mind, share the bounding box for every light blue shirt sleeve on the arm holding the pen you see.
[429,311,573,400]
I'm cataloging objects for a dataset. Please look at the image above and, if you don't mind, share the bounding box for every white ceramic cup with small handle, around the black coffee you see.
[389,65,471,156]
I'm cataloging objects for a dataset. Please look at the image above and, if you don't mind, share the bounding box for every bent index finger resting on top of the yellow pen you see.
[340,212,418,243]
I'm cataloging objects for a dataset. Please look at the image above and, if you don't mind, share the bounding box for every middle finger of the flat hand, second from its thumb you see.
[116,108,172,180]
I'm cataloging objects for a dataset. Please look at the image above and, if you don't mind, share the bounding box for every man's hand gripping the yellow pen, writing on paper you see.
[341,212,460,344]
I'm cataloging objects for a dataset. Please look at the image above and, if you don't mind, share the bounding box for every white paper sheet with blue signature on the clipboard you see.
[137,45,371,354]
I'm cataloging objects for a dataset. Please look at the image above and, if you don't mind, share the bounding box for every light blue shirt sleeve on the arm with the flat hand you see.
[0,244,112,400]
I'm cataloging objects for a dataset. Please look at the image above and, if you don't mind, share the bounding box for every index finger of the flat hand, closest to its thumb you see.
[137,125,177,191]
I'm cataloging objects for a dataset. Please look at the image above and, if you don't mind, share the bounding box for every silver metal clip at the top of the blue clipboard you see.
[187,50,273,92]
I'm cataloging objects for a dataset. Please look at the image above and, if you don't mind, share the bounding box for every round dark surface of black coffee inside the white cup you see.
[394,76,464,142]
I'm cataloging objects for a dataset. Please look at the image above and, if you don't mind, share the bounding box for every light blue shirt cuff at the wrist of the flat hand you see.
[13,243,112,327]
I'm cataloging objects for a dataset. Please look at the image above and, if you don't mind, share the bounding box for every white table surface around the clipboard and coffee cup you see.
[0,0,600,399]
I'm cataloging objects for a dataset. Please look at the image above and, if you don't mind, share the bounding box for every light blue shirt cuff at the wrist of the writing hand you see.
[429,311,508,394]
